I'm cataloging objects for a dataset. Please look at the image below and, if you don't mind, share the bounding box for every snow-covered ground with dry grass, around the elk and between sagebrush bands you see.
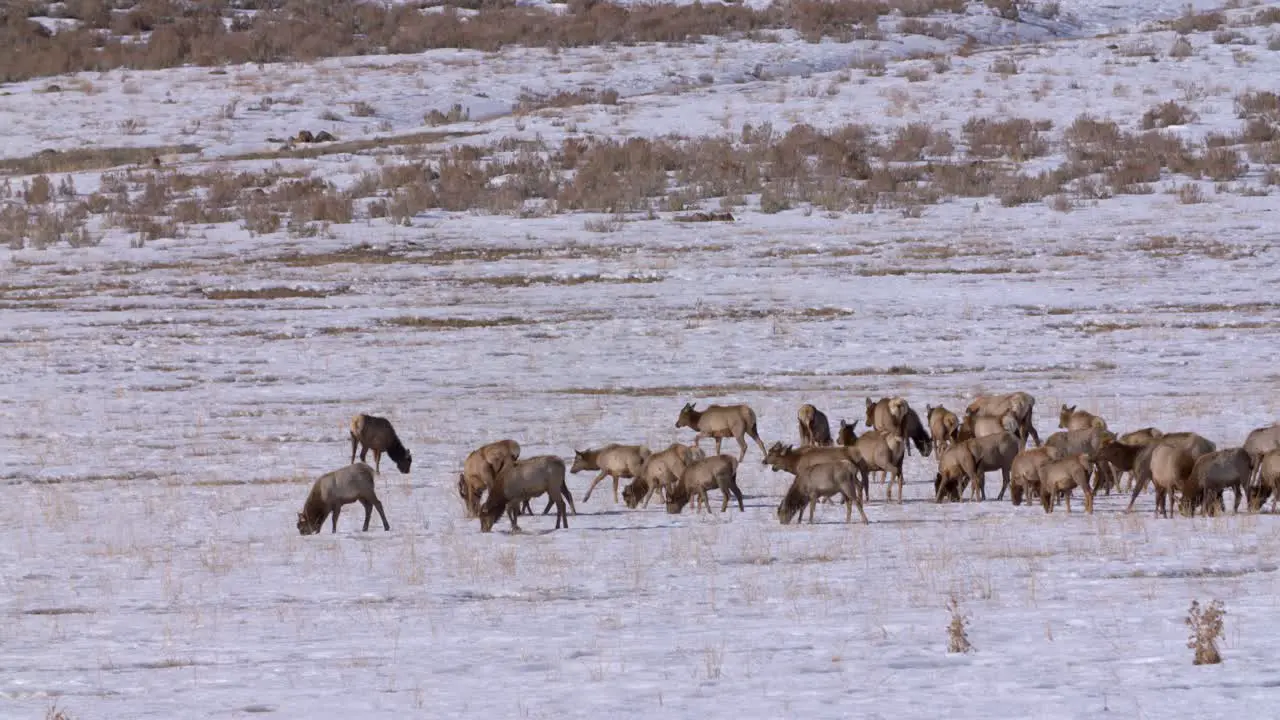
[0,3,1280,720]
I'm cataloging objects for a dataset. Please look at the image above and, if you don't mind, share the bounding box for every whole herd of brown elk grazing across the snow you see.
[298,392,1280,534]
